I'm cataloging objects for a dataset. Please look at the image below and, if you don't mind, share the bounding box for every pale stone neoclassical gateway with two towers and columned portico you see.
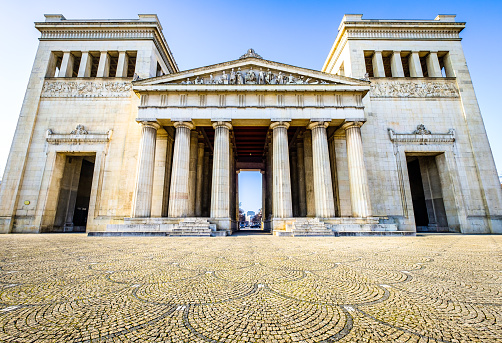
[0,14,502,236]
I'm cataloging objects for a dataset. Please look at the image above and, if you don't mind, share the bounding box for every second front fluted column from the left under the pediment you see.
[169,121,195,218]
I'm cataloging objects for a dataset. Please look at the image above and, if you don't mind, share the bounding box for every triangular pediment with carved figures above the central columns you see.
[134,56,369,86]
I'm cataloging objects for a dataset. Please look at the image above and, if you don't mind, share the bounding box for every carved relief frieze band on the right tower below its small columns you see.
[370,78,459,98]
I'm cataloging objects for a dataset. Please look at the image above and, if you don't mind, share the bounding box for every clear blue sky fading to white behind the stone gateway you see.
[0,0,502,211]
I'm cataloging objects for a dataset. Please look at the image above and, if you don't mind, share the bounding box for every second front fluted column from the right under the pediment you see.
[308,121,335,218]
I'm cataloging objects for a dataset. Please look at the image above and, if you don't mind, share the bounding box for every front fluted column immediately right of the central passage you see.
[270,122,293,218]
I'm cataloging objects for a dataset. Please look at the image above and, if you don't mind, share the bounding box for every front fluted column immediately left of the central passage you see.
[211,121,232,218]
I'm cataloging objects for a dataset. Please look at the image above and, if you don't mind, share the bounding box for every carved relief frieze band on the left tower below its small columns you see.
[42,80,132,98]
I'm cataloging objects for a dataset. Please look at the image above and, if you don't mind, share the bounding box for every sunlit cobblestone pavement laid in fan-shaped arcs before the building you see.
[0,234,502,342]
